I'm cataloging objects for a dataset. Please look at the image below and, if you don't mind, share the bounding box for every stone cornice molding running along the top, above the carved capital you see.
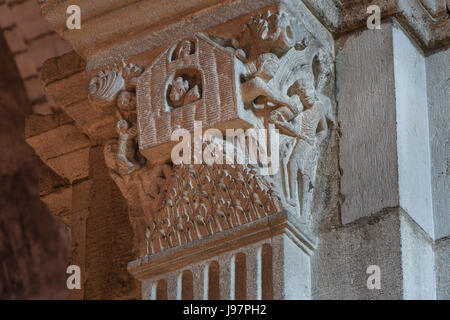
[40,0,450,70]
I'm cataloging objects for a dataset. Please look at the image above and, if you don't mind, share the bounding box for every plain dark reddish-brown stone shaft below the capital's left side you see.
[83,147,140,299]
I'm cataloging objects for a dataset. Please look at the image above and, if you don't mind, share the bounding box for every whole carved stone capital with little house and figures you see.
[93,8,335,256]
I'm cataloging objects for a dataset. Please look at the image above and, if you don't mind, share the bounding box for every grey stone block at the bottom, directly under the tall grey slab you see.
[311,209,403,300]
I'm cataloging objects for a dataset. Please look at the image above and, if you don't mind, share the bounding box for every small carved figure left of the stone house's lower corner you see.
[117,119,140,175]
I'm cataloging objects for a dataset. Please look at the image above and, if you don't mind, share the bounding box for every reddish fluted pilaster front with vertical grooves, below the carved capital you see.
[143,242,281,300]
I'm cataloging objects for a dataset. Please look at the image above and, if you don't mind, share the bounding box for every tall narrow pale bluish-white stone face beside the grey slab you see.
[393,26,434,237]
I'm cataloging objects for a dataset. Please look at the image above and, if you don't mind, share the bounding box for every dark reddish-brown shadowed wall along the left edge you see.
[0,5,69,299]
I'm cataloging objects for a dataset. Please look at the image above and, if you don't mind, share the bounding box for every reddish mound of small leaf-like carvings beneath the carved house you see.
[105,143,282,256]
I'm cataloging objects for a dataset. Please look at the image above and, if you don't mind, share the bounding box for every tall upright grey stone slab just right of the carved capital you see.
[336,23,399,224]
